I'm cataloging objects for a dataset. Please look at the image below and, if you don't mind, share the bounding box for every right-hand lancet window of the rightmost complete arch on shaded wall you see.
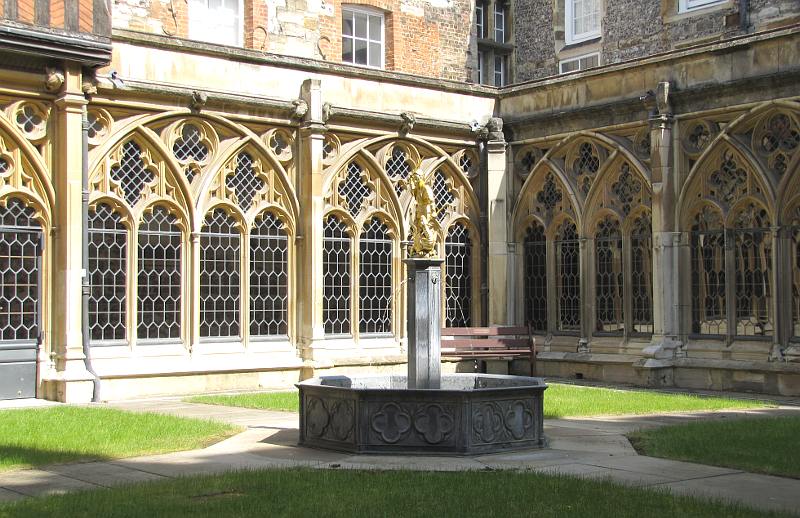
[733,205,774,336]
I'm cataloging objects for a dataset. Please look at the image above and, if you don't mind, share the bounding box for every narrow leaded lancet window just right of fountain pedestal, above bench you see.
[444,223,472,327]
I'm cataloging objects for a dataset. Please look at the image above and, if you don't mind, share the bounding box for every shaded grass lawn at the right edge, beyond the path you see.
[629,417,800,478]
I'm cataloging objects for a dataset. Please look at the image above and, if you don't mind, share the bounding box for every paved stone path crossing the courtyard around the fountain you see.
[0,399,800,513]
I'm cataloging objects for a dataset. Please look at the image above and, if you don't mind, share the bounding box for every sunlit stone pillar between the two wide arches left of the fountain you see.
[295,79,327,360]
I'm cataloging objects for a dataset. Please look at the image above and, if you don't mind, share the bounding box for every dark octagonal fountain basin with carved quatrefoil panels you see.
[297,374,547,455]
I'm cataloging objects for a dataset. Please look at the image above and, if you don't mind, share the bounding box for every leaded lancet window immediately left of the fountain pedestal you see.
[358,218,392,333]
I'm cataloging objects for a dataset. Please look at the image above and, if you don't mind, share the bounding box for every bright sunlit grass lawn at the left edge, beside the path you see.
[0,406,239,478]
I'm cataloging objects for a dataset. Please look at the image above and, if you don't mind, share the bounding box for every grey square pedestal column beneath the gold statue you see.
[405,258,442,389]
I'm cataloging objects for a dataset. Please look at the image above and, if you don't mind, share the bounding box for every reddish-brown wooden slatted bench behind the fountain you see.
[441,327,536,376]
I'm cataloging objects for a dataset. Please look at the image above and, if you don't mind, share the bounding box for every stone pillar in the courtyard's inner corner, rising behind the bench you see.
[484,117,506,325]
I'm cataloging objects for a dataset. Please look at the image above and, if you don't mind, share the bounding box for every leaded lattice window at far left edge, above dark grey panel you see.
[0,198,41,341]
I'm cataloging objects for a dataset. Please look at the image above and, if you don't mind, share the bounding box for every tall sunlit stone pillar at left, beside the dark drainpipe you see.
[42,63,94,403]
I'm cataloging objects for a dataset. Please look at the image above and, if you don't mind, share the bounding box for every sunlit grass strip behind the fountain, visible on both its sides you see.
[186,383,767,418]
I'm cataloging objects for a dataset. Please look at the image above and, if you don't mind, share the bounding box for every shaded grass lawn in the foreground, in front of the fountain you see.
[0,469,789,518]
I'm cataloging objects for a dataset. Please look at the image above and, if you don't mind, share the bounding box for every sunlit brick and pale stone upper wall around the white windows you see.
[113,0,474,81]
